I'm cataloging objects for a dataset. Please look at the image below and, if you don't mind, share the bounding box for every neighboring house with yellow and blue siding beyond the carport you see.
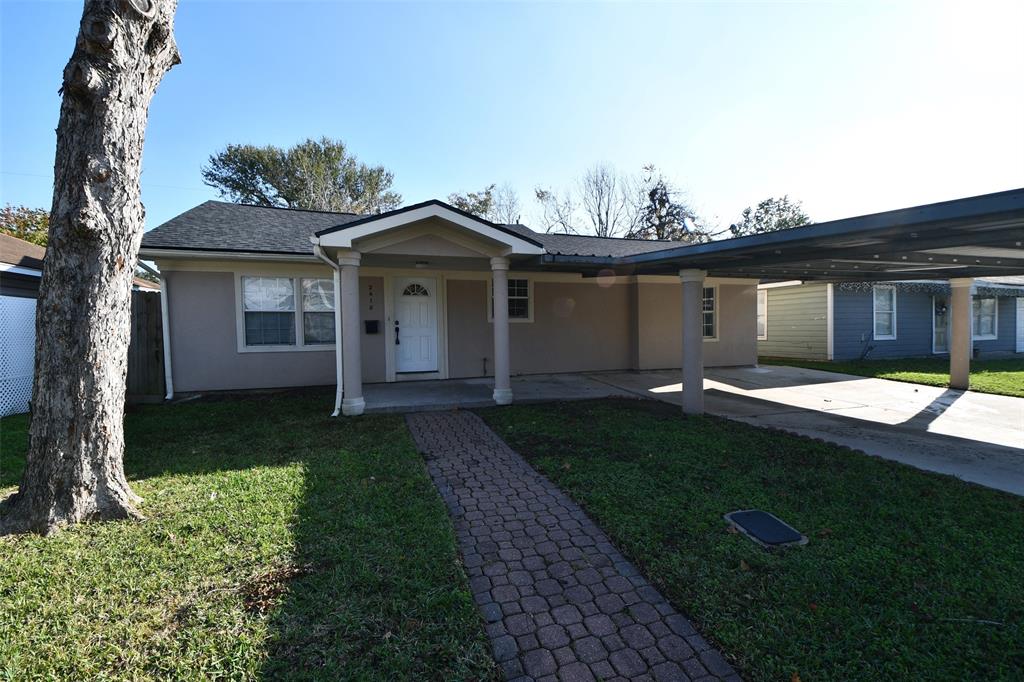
[758,278,1024,360]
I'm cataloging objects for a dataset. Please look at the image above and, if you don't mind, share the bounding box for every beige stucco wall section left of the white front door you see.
[164,270,385,392]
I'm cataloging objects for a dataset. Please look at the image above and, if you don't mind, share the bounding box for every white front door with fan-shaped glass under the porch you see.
[393,278,437,372]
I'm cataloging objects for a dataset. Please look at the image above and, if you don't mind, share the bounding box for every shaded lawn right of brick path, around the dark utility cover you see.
[481,400,1024,681]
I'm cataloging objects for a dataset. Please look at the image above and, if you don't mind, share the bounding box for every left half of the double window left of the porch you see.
[242,276,295,346]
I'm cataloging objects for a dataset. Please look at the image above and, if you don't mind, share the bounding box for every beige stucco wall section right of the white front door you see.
[447,280,757,378]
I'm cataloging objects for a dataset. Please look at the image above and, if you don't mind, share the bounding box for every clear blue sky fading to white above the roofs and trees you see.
[0,0,1024,227]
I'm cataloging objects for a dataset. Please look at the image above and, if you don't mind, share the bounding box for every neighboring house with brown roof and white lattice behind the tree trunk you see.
[0,232,159,417]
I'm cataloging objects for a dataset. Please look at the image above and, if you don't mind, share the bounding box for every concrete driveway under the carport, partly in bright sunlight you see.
[591,367,1024,495]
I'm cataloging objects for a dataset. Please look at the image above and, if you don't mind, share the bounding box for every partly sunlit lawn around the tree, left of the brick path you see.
[0,396,497,680]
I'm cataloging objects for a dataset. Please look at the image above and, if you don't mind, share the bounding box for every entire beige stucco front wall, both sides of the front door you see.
[165,266,757,392]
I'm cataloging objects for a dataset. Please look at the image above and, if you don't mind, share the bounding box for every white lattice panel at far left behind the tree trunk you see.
[0,296,36,417]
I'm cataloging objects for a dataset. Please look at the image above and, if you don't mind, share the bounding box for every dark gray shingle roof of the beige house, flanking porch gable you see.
[142,201,679,257]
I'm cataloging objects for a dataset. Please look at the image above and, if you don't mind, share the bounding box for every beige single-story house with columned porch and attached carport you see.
[141,189,1024,415]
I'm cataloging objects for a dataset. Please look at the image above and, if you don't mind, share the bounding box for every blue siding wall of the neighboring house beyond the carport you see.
[833,286,1017,360]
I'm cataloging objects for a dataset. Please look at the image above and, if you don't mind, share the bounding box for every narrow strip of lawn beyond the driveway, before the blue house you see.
[758,357,1024,397]
